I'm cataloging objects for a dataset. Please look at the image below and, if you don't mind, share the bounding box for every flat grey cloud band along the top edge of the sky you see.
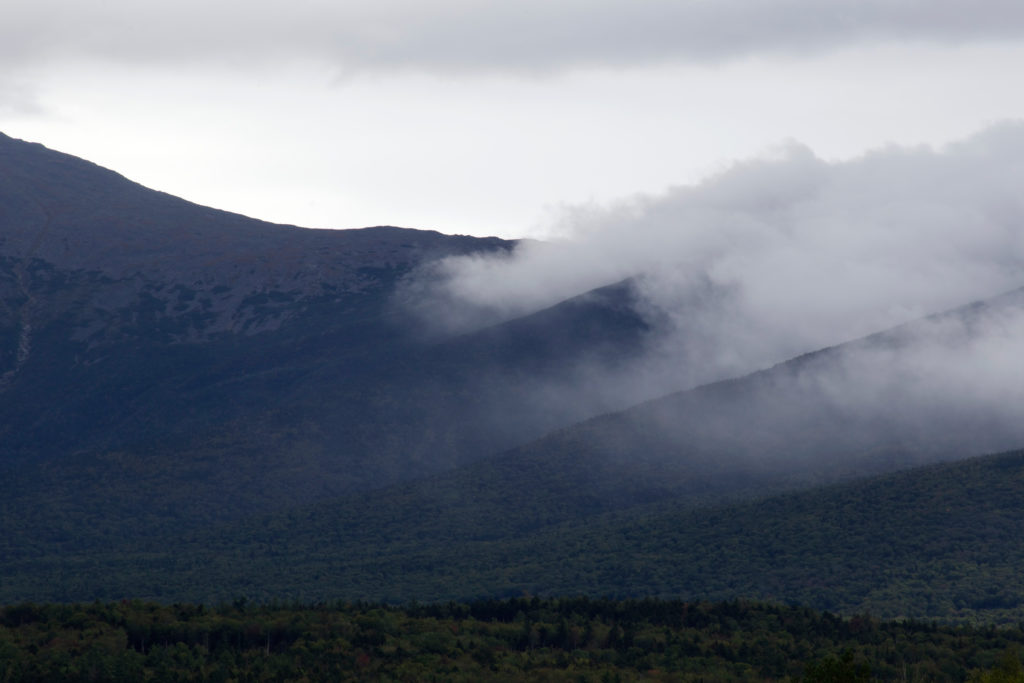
[6,0,1024,73]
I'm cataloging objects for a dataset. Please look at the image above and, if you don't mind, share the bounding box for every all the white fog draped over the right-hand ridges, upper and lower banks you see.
[395,123,1024,466]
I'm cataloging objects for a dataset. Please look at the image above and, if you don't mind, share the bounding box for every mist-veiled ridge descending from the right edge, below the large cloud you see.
[245,282,1024,561]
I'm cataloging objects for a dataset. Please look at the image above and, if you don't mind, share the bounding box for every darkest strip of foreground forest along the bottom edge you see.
[0,598,1024,682]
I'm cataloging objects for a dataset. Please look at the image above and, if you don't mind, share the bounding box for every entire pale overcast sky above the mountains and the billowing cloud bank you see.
[0,0,1024,237]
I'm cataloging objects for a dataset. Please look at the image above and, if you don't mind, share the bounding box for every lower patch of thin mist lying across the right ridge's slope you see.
[638,289,1024,485]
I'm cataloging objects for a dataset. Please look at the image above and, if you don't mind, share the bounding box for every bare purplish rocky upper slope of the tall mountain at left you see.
[0,134,512,352]
